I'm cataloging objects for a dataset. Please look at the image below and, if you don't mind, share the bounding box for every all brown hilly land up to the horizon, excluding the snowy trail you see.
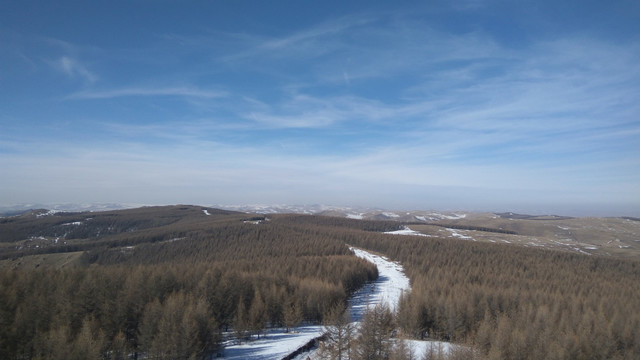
[0,205,640,359]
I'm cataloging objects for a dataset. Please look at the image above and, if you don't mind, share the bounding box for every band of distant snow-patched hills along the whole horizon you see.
[5,204,640,257]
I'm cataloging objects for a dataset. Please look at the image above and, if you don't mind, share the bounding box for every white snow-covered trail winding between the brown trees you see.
[224,248,409,360]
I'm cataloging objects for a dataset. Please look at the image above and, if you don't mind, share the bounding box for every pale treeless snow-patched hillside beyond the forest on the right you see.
[246,205,640,258]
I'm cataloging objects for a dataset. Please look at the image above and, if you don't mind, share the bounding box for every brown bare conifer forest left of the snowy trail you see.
[0,213,377,359]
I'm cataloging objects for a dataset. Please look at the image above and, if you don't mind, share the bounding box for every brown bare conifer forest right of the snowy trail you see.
[350,236,640,359]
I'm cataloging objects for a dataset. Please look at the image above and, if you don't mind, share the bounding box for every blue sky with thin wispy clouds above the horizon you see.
[0,0,640,216]
